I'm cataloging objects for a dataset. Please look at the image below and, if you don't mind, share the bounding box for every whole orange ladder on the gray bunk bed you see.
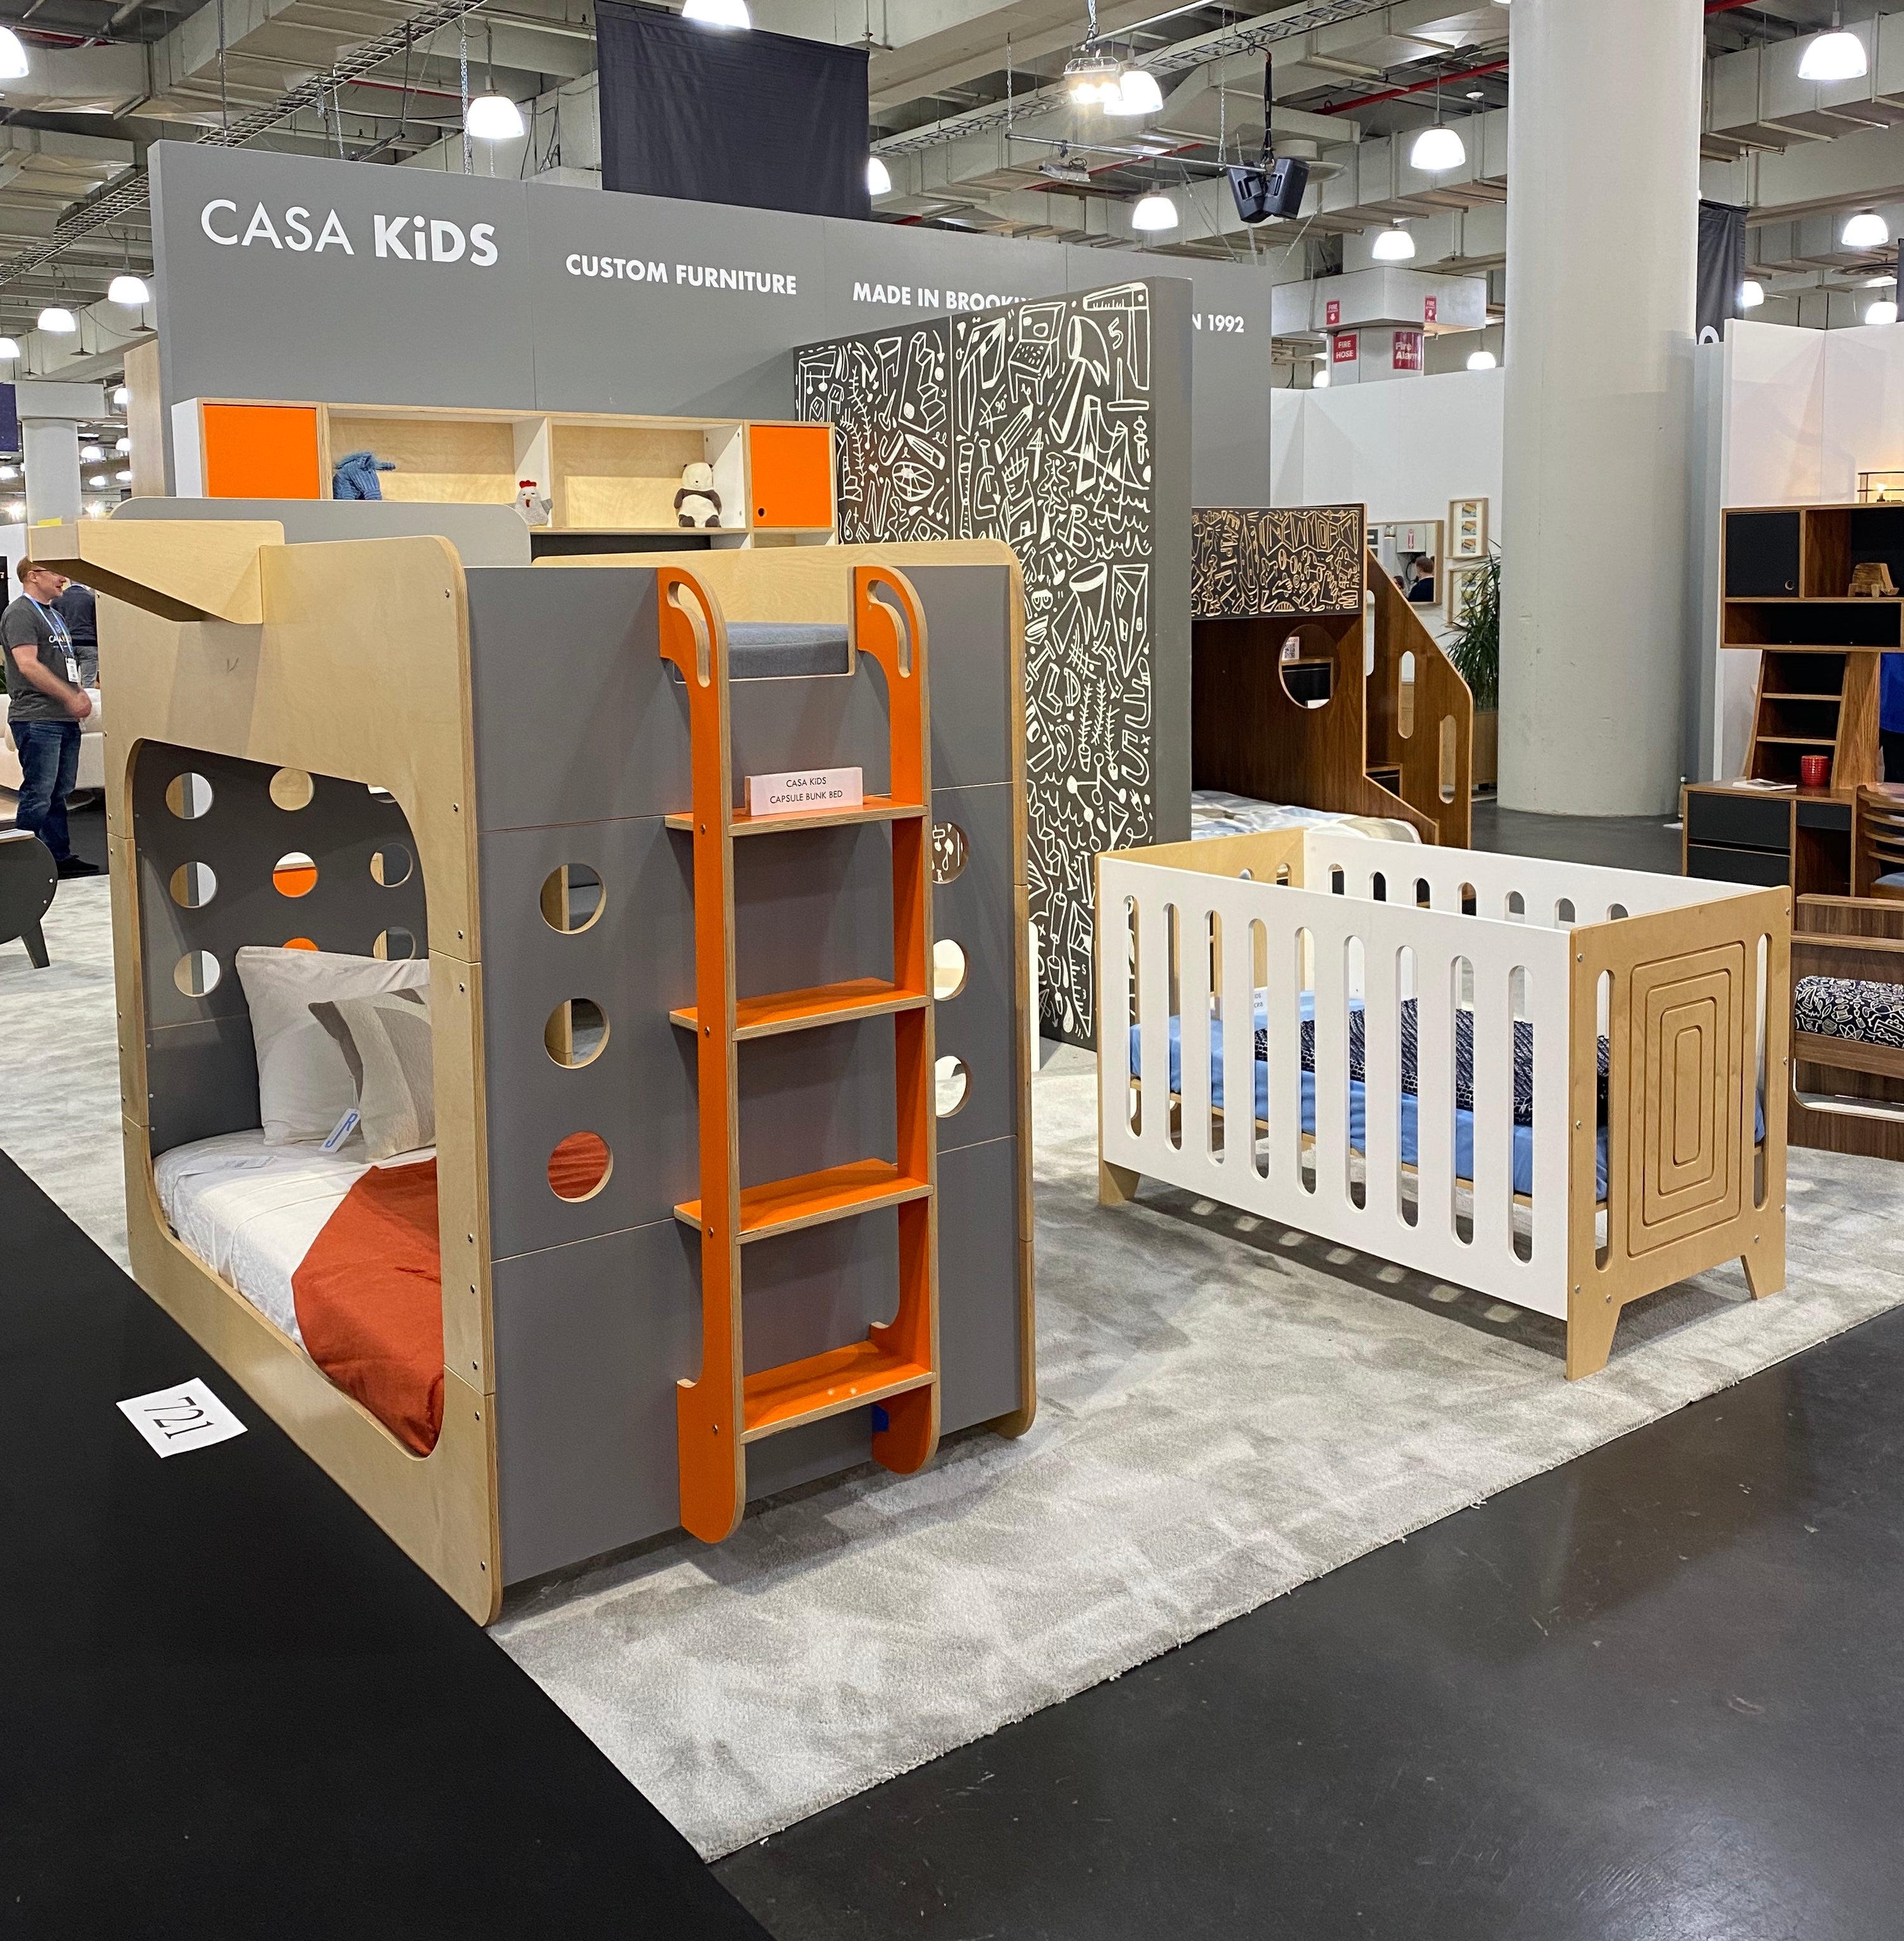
[654,567,940,1543]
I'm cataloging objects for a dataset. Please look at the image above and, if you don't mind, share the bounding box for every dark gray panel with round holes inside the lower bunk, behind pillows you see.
[132,741,429,1155]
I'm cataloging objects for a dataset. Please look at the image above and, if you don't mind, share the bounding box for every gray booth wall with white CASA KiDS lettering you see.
[151,142,1273,505]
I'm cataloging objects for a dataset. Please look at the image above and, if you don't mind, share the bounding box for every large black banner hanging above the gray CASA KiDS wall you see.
[596,0,871,217]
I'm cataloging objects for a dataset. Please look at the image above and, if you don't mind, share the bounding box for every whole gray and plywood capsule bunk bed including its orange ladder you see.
[44,518,1035,1621]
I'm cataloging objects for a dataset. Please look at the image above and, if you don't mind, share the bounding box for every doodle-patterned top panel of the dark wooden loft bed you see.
[1190,505,1366,619]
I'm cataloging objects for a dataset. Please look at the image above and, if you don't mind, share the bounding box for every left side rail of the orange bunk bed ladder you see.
[654,567,747,1543]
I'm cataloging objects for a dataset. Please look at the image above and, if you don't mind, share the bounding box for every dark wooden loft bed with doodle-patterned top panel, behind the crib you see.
[1190,506,1473,848]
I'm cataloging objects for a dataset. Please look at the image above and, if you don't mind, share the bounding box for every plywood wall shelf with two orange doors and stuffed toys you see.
[173,398,833,548]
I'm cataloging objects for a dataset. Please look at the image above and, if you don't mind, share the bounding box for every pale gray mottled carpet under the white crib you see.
[495,1073,1904,1857]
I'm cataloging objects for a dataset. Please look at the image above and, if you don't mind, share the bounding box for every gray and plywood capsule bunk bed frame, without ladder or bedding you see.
[44,520,1037,1623]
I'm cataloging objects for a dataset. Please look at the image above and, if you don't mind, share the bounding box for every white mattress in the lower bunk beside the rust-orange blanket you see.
[153,1128,376,1347]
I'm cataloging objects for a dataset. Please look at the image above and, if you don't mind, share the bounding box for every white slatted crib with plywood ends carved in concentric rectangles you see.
[1097,829,1791,1380]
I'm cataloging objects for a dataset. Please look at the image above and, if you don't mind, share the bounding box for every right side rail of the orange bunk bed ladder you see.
[852,567,940,1475]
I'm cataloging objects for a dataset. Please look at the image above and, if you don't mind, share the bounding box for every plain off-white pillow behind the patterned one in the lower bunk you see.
[235,943,429,1145]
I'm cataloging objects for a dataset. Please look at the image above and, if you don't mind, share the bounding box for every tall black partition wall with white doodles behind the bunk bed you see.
[798,284,1157,1042]
